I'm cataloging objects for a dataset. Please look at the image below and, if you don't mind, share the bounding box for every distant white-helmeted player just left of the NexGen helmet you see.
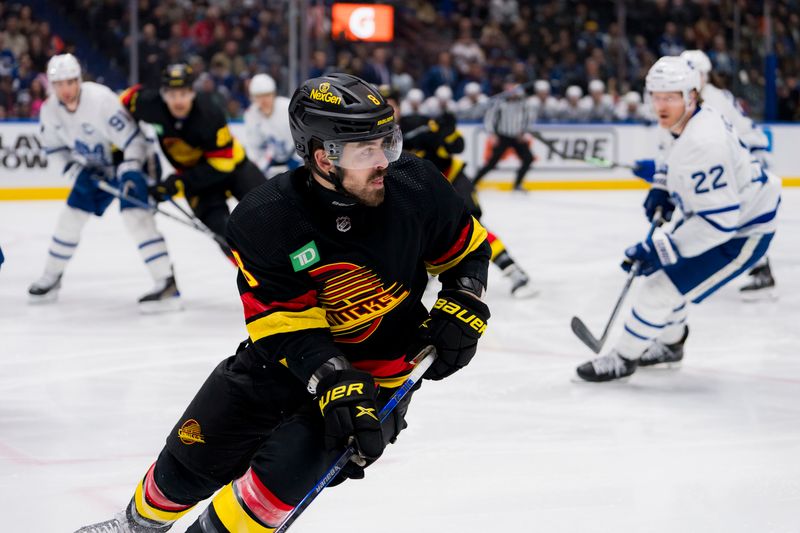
[244,74,301,176]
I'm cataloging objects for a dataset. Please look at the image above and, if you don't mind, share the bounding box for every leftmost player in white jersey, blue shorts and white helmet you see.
[28,54,180,313]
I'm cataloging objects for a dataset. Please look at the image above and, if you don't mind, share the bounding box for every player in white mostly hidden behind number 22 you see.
[681,50,775,299]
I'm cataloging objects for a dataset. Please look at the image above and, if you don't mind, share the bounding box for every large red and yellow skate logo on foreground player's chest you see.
[309,263,409,344]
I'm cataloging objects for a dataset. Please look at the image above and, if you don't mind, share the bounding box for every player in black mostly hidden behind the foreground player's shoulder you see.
[380,86,537,298]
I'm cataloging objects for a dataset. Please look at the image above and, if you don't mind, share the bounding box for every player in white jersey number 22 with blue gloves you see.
[577,57,780,381]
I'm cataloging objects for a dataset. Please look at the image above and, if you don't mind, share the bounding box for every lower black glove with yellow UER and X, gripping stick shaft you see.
[317,369,386,464]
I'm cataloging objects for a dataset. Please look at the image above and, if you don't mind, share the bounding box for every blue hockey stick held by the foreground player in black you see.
[275,346,436,533]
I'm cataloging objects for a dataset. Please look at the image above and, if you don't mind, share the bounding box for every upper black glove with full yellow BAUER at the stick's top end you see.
[420,289,491,380]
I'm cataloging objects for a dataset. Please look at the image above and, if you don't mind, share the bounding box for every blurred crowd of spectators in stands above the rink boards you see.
[0,0,800,122]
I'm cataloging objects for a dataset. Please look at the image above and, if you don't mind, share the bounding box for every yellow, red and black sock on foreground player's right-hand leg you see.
[194,468,294,533]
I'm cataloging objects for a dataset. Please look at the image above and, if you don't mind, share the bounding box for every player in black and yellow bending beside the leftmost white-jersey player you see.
[121,63,266,253]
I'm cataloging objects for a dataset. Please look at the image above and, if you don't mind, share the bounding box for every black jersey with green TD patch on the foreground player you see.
[227,154,490,386]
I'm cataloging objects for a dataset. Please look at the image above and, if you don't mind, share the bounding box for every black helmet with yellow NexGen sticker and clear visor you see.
[289,73,402,164]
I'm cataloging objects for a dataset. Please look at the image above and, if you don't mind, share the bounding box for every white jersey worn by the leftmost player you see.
[40,81,147,173]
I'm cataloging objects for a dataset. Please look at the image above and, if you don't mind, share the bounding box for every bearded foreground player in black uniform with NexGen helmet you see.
[79,74,491,533]
